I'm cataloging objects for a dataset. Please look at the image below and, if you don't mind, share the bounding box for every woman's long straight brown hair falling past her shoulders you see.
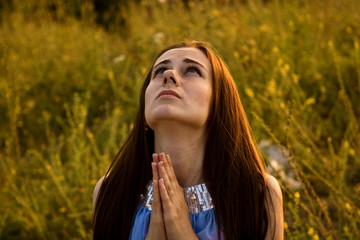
[93,41,269,239]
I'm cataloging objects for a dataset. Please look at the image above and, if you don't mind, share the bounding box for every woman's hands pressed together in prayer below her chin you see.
[146,153,198,240]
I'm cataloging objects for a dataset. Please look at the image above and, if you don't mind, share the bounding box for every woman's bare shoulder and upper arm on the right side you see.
[265,174,284,240]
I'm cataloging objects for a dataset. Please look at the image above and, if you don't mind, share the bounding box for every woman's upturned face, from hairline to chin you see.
[145,48,212,130]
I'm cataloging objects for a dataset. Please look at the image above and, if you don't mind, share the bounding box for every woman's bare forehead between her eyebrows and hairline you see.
[154,47,211,69]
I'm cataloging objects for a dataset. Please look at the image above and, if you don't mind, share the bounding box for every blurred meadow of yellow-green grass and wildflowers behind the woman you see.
[0,0,360,240]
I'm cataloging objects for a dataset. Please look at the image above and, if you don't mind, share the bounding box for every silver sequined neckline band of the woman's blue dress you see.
[141,181,214,214]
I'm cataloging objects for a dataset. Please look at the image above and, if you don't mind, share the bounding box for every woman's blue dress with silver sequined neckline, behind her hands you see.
[129,182,223,240]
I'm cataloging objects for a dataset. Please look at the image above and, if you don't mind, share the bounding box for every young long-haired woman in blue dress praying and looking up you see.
[94,41,283,240]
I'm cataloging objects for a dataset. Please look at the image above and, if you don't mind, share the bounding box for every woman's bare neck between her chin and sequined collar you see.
[154,126,206,187]
